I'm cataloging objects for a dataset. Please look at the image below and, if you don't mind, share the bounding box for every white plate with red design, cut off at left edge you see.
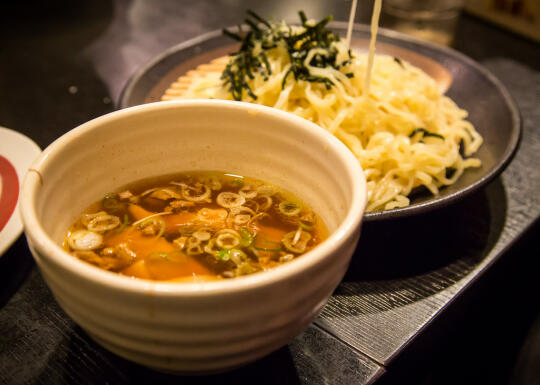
[0,126,41,256]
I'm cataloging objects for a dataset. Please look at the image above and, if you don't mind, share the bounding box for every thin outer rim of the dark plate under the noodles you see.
[117,21,523,222]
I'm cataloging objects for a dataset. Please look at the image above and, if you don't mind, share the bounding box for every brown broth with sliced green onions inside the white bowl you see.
[63,172,327,282]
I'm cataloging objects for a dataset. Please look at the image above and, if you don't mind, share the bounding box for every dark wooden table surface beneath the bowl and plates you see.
[0,0,540,384]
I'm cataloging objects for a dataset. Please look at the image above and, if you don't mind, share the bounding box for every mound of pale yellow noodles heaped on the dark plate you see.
[162,27,482,211]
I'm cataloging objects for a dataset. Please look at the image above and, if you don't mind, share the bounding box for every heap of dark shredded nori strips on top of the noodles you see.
[221,10,354,100]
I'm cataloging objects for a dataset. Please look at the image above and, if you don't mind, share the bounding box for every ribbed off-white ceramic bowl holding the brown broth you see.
[20,100,366,373]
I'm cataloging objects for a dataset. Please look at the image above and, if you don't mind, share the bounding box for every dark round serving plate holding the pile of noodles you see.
[118,22,521,221]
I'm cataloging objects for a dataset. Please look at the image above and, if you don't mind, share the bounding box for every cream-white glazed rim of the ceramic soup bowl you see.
[20,99,367,297]
